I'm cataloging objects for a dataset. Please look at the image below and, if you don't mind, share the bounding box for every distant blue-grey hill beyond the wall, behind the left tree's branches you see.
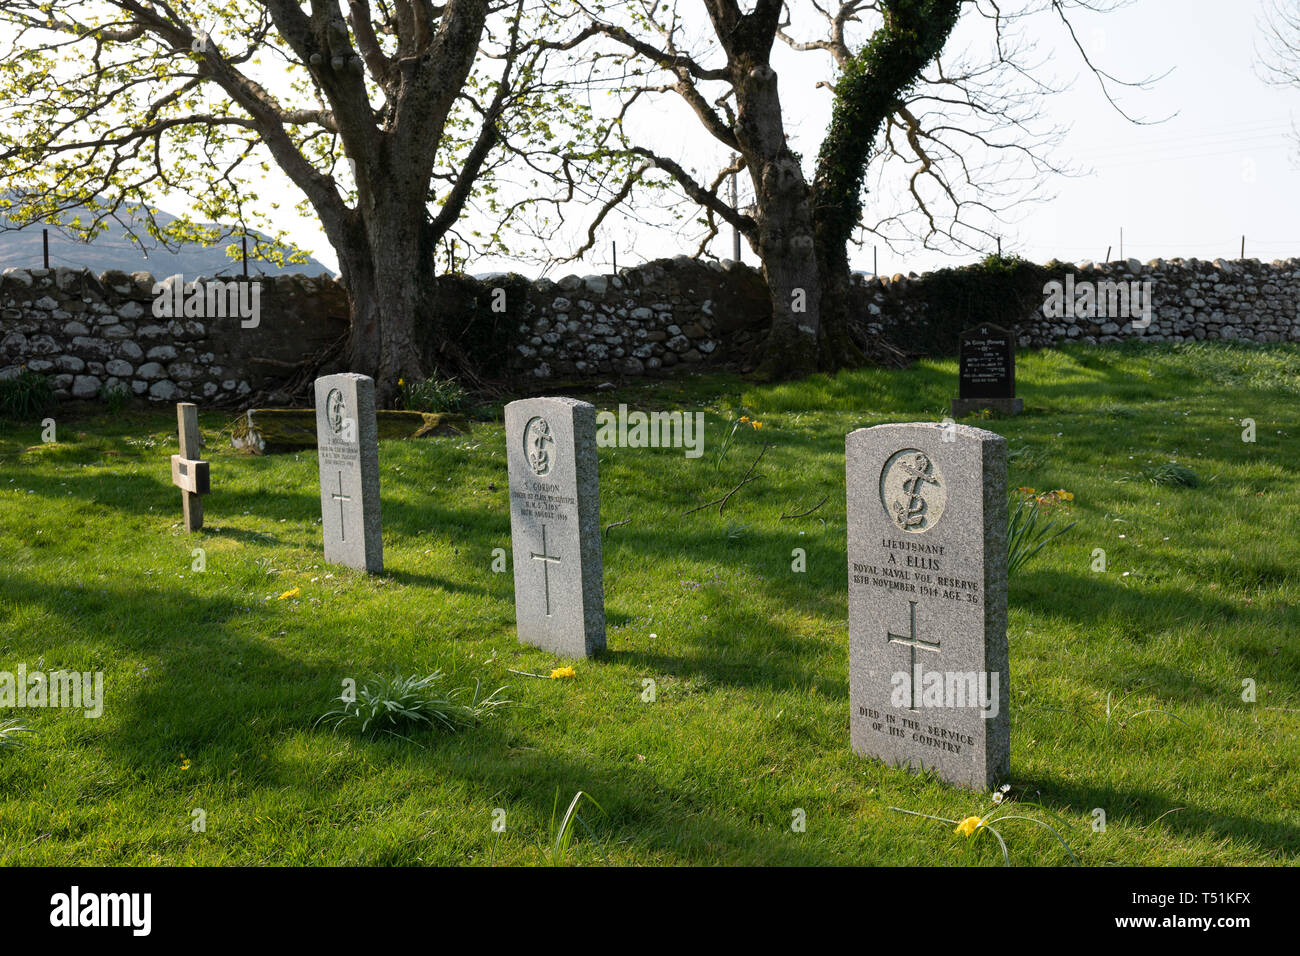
[0,195,334,277]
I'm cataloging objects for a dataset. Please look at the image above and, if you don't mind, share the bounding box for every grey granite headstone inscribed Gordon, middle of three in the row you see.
[506,398,605,657]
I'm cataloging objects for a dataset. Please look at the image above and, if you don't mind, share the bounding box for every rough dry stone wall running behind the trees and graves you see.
[0,256,1300,403]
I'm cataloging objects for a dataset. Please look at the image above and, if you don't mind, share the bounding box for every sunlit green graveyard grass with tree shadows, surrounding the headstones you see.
[0,345,1300,866]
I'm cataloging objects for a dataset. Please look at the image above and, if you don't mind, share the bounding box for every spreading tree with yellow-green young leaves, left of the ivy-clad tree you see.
[0,0,603,403]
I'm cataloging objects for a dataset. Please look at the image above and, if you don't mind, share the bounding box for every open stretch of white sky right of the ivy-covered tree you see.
[982,0,1300,271]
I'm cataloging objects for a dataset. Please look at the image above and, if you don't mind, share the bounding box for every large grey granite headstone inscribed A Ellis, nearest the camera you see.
[845,423,1010,790]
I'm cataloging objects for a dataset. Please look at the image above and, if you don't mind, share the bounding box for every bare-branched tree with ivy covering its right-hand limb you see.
[556,0,1152,376]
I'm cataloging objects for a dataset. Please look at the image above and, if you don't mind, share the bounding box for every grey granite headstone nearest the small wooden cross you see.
[316,372,384,574]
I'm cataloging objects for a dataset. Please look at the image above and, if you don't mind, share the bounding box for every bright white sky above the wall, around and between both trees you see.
[94,0,1300,274]
